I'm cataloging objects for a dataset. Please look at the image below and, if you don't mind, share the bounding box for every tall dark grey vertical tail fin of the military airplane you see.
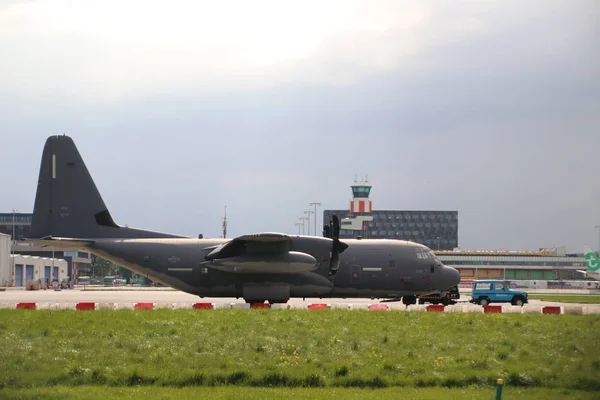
[31,135,183,240]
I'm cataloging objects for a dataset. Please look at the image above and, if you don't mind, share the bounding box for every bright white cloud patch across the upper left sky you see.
[0,0,508,101]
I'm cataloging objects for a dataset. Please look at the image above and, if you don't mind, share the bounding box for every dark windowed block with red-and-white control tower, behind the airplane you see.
[323,179,458,250]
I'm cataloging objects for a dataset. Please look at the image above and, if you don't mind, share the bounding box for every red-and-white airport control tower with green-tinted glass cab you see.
[341,177,373,238]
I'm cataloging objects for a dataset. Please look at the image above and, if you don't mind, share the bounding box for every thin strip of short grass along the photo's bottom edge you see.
[0,386,598,400]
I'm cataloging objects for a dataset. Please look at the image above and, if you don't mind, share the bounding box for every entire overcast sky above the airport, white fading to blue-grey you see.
[0,0,600,252]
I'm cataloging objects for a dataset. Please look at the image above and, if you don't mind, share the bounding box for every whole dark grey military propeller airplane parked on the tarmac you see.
[28,135,460,304]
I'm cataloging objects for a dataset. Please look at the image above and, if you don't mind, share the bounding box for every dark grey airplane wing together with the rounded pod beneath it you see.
[202,232,317,274]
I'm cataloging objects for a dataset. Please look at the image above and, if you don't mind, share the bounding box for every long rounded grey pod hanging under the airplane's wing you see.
[202,251,317,274]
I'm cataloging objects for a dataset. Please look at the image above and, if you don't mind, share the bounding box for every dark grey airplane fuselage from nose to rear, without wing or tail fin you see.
[78,236,459,301]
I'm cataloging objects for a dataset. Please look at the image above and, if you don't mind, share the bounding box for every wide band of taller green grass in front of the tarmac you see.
[0,310,600,393]
